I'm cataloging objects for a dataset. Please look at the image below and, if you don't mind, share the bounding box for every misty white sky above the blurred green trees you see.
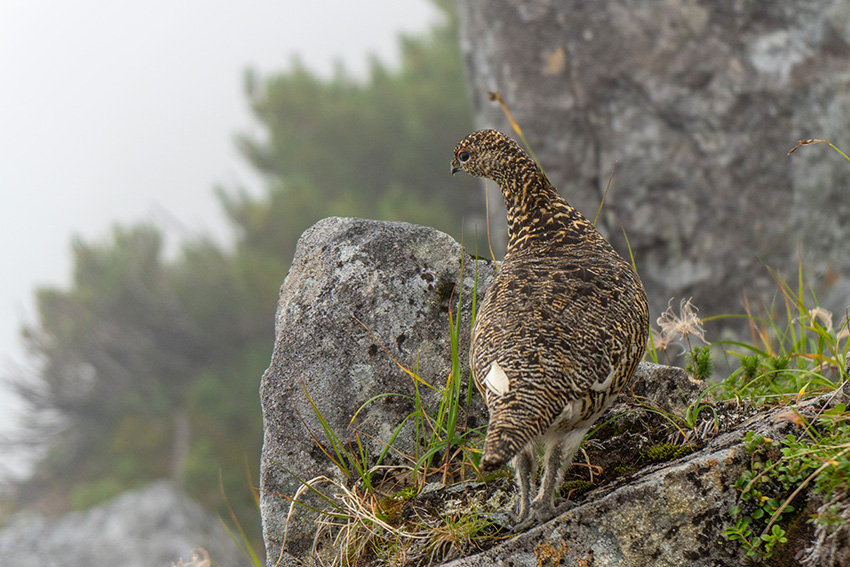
[0,0,437,480]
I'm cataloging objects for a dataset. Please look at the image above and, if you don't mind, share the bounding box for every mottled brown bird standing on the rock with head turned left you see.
[452,130,649,528]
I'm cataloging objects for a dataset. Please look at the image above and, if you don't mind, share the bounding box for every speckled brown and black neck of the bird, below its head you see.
[496,155,598,253]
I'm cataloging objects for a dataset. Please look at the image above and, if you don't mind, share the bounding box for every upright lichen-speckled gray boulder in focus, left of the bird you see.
[260,218,494,565]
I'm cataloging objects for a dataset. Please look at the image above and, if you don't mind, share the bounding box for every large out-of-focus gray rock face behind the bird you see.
[458,0,850,328]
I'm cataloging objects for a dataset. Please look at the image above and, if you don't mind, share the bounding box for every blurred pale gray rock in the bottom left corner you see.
[0,482,242,567]
